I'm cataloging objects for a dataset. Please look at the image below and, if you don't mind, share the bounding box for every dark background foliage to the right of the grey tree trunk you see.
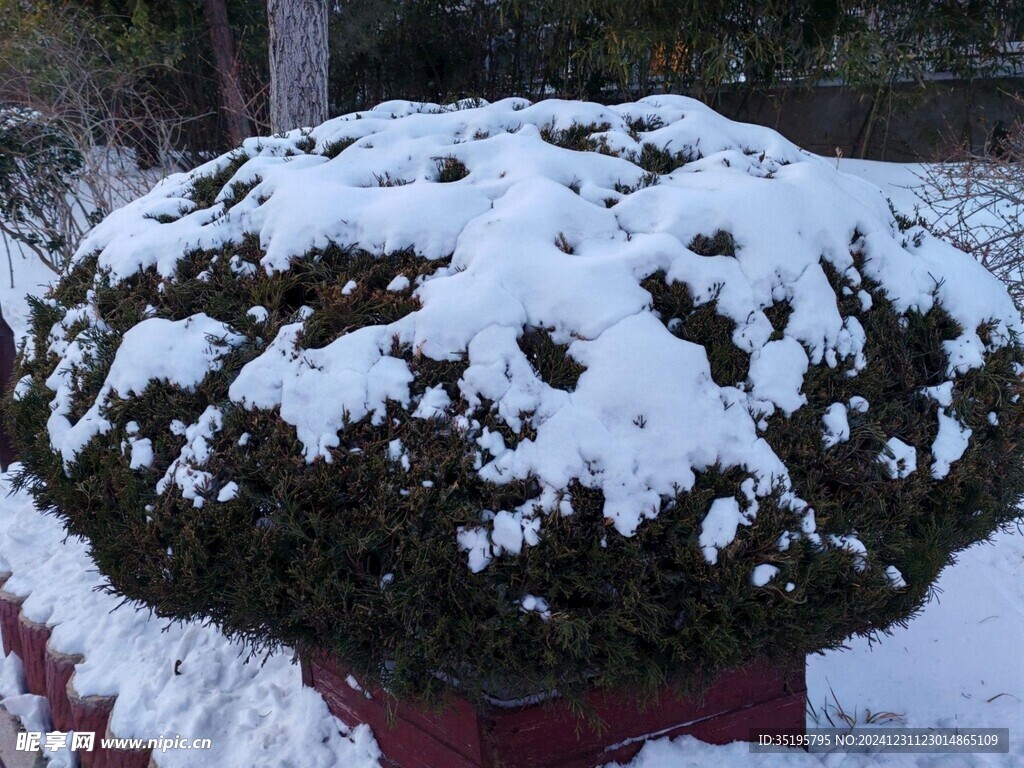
[323,0,1024,111]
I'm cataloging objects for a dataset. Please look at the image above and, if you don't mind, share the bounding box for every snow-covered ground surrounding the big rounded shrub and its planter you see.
[0,161,1024,768]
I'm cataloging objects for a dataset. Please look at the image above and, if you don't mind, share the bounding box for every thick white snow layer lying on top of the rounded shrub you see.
[58,96,1024,569]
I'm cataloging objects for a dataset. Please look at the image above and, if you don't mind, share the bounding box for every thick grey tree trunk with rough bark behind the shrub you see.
[266,0,328,132]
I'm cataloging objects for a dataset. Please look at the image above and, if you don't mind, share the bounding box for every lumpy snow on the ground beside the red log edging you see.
[0,475,379,768]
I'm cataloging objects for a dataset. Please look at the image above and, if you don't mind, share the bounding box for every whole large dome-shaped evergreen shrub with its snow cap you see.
[7,96,1024,708]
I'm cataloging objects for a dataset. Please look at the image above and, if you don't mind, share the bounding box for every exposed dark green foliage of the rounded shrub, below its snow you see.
[5,137,1024,716]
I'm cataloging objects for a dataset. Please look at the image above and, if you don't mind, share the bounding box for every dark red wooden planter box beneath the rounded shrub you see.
[302,654,807,768]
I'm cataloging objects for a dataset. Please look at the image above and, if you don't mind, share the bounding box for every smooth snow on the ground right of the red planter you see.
[614,532,1024,768]
